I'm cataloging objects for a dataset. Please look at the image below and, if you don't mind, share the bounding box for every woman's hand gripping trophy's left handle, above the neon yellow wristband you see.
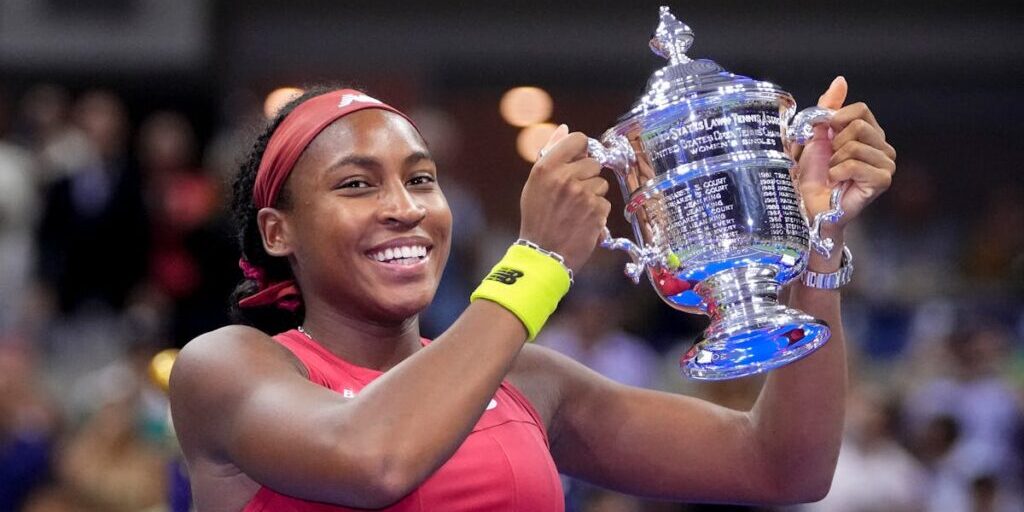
[519,125,611,271]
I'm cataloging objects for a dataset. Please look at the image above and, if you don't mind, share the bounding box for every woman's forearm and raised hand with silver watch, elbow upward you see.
[751,78,896,498]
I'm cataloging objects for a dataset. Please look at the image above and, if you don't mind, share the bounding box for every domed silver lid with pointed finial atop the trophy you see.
[624,6,785,121]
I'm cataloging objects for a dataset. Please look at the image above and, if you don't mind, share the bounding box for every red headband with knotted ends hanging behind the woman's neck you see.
[239,89,416,311]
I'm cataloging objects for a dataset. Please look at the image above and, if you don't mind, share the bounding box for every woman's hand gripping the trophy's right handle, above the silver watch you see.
[791,77,896,236]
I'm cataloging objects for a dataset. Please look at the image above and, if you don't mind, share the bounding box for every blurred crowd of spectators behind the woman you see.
[0,84,1024,512]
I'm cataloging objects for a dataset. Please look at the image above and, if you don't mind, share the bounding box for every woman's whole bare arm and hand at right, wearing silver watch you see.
[540,79,895,503]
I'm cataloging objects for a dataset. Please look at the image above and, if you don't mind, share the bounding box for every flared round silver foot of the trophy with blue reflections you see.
[679,265,830,380]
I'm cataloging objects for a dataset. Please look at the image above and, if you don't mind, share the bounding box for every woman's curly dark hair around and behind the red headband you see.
[230,85,345,334]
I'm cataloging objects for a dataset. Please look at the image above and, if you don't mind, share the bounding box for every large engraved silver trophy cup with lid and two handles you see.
[589,7,843,380]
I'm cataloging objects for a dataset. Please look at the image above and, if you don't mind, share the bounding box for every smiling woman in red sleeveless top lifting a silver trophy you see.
[170,79,895,512]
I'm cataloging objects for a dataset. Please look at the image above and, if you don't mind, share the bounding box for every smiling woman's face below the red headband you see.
[272,109,452,324]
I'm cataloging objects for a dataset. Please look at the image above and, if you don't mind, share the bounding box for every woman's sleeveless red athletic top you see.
[243,330,564,512]
